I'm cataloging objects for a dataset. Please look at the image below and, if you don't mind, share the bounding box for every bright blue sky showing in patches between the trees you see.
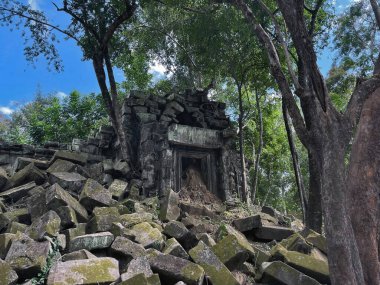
[0,0,350,115]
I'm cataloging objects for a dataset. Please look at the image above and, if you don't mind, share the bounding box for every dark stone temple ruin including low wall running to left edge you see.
[0,90,241,201]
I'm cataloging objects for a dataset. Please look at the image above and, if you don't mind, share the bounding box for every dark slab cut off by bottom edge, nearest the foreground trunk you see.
[260,261,321,285]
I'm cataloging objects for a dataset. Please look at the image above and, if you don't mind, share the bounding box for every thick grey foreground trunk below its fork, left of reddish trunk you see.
[322,138,369,285]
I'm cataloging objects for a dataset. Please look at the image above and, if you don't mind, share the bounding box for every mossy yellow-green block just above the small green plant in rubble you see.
[26,211,61,240]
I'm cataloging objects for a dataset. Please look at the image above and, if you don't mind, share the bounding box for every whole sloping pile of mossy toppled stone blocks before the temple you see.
[0,150,330,285]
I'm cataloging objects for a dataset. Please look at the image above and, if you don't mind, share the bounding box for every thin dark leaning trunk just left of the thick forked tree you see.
[282,100,307,223]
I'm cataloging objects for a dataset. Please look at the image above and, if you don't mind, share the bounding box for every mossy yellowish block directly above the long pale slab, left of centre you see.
[87,207,119,233]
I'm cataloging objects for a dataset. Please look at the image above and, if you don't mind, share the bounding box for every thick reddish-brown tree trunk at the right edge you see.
[347,89,380,285]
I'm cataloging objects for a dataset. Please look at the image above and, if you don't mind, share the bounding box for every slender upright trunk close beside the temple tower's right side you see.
[237,84,247,202]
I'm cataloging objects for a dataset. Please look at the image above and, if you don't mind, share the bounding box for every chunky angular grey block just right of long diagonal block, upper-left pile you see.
[79,178,112,211]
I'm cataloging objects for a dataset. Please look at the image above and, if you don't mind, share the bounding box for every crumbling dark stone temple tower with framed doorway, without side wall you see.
[122,87,245,200]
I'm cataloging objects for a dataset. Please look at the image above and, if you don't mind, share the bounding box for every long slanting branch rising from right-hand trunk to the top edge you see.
[231,0,309,145]
